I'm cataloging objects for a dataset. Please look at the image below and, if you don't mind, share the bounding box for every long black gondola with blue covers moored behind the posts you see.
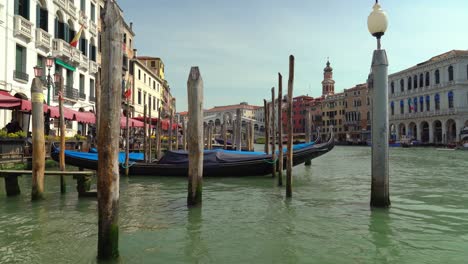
[51,136,334,177]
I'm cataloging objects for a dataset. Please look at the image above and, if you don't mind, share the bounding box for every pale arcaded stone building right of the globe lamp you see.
[388,50,468,144]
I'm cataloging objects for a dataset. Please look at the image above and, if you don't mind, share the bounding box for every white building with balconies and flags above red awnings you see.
[0,0,99,134]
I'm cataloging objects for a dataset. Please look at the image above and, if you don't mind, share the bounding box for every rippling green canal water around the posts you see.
[0,147,468,263]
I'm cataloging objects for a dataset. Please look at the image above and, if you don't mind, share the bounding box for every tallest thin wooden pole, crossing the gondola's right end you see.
[286,55,294,197]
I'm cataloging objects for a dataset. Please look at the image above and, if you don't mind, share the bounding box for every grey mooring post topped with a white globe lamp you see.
[367,0,390,207]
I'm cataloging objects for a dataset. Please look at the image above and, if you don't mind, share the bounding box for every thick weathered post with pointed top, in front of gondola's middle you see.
[187,67,203,206]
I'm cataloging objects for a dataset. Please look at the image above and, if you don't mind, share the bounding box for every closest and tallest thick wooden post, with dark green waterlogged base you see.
[97,1,123,259]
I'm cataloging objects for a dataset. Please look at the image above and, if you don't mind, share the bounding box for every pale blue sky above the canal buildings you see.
[119,0,468,111]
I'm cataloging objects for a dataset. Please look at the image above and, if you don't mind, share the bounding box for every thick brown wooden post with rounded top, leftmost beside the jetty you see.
[31,77,45,200]
